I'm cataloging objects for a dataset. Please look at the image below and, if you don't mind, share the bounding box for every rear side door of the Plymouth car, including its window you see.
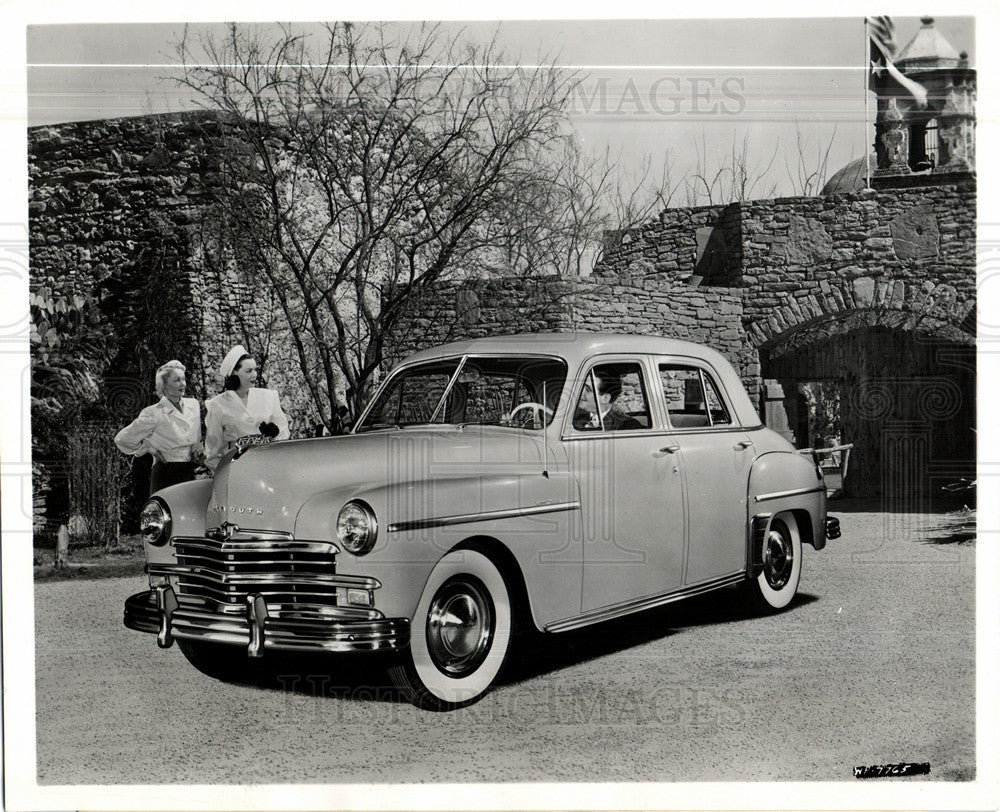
[656,357,754,586]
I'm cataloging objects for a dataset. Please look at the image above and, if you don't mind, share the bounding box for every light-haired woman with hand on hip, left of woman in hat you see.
[115,361,205,493]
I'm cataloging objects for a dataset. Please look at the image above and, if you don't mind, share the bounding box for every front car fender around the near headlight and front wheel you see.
[295,468,581,626]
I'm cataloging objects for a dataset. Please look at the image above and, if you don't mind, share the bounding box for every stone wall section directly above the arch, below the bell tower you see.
[740,186,976,346]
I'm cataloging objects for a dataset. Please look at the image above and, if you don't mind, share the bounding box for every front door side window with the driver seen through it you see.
[573,361,652,431]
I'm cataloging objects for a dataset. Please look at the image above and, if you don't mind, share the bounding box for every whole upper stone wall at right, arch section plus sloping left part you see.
[594,182,976,346]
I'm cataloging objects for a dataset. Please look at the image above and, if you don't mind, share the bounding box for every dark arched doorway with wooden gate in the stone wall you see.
[760,311,976,510]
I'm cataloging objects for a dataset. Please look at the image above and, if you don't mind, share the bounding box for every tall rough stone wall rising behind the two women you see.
[28,113,314,431]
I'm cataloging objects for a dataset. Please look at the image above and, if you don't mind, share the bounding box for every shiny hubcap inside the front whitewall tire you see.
[427,575,494,677]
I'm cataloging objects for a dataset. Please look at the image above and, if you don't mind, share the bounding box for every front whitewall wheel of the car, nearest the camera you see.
[389,550,513,710]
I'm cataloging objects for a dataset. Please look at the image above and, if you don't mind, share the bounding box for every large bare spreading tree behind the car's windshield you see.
[179,23,577,424]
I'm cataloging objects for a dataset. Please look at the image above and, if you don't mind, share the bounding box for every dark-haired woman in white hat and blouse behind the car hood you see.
[205,346,290,471]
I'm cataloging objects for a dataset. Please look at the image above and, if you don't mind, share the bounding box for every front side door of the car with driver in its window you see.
[563,356,684,612]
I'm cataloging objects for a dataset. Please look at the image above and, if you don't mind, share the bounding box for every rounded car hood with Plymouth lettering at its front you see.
[205,426,555,533]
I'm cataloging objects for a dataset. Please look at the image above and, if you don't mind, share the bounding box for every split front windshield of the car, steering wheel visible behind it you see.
[357,356,566,432]
